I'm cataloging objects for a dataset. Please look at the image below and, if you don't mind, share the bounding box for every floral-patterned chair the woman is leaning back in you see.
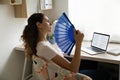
[32,56,92,80]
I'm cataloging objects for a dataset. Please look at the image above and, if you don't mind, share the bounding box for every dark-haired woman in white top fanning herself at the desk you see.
[21,13,92,79]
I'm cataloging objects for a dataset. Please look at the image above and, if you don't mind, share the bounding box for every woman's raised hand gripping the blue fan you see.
[74,30,84,46]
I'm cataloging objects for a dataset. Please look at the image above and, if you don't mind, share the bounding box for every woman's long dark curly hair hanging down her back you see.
[21,13,44,58]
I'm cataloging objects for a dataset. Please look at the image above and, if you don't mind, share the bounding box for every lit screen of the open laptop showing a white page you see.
[91,32,110,50]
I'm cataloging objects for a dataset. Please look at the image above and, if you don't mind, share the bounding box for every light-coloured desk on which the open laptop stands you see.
[16,42,120,80]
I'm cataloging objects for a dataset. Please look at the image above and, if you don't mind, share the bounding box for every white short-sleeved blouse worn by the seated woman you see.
[36,41,63,60]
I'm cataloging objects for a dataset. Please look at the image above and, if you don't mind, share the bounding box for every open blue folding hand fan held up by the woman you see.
[54,13,75,55]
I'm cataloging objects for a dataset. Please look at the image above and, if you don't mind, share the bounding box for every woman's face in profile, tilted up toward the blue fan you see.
[40,16,51,34]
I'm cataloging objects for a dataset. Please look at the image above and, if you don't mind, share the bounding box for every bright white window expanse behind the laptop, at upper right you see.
[69,0,120,42]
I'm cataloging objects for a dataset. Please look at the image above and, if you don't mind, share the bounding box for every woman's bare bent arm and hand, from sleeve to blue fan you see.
[52,30,84,72]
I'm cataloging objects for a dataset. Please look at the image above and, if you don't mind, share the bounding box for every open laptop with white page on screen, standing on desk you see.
[81,32,110,54]
